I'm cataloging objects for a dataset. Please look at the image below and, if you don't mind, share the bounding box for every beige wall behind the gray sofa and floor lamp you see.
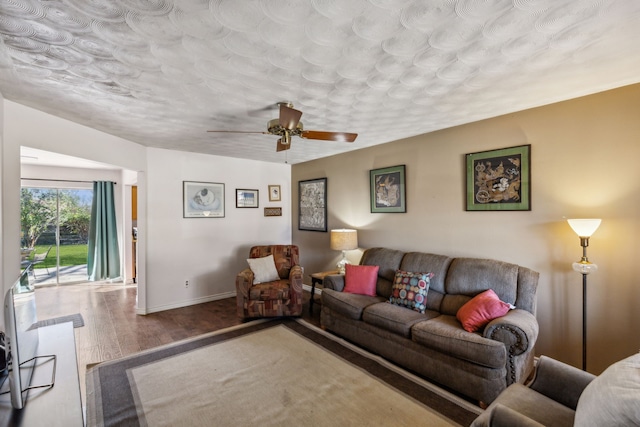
[292,85,640,373]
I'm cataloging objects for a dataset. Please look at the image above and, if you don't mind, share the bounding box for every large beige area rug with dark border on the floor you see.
[87,319,480,426]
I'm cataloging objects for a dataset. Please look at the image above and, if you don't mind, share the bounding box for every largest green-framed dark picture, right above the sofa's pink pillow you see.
[466,145,531,211]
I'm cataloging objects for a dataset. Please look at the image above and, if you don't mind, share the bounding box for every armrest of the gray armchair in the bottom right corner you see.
[530,356,595,411]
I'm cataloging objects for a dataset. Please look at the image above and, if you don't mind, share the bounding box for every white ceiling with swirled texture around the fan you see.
[0,0,640,163]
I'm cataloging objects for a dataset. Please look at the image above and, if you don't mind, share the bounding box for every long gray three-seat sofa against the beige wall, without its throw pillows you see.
[321,248,538,404]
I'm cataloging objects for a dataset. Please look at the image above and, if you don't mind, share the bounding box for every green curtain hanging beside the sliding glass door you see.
[87,181,120,281]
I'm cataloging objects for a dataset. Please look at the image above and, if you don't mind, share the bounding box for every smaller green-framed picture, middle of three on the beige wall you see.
[369,165,407,213]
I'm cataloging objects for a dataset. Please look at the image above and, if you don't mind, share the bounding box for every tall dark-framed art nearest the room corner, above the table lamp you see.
[298,178,327,232]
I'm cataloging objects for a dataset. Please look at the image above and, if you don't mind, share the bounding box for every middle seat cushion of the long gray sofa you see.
[362,303,440,338]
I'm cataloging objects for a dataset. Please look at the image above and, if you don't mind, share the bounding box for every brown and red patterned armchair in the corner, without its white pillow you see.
[236,245,302,319]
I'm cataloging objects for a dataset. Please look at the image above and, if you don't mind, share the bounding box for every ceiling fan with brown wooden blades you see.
[207,102,358,151]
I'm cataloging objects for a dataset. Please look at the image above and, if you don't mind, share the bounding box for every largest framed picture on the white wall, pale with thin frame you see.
[182,181,224,218]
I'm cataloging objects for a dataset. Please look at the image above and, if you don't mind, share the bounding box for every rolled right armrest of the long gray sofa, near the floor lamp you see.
[483,308,539,356]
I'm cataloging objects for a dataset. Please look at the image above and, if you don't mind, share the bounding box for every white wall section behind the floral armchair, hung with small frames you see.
[146,148,291,311]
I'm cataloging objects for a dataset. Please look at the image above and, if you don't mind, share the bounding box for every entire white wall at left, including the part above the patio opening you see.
[0,100,291,314]
